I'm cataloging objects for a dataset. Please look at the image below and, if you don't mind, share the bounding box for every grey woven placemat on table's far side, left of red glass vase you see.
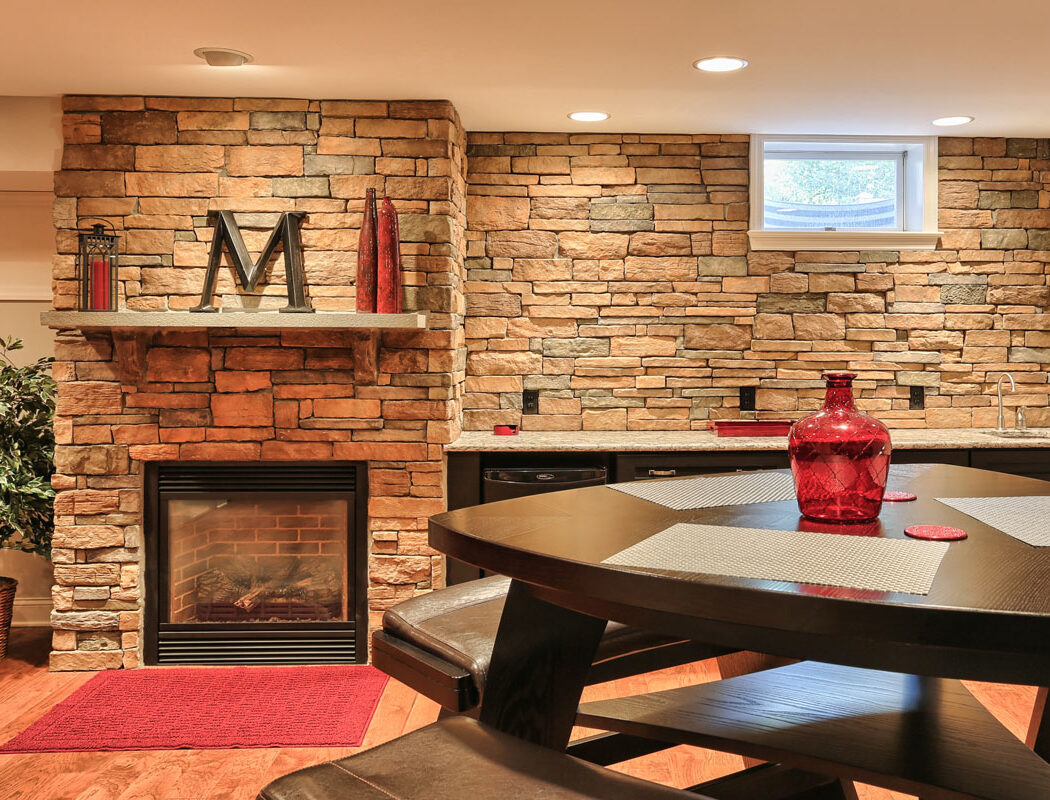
[609,471,795,511]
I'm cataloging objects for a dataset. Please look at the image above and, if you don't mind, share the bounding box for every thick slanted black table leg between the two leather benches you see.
[478,581,606,750]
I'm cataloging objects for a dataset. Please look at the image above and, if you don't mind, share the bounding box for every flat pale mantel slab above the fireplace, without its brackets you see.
[40,311,426,331]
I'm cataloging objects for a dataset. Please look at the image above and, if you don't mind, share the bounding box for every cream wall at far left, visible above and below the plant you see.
[0,98,62,625]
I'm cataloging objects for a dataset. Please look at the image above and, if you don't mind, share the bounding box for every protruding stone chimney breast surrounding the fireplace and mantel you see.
[51,97,465,670]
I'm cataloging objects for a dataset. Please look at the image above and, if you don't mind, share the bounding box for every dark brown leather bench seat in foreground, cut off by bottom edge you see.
[258,717,704,800]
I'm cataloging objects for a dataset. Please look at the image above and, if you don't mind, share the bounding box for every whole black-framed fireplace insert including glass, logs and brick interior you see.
[143,462,368,665]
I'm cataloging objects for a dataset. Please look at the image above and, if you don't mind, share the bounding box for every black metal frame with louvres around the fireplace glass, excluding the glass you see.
[141,461,371,666]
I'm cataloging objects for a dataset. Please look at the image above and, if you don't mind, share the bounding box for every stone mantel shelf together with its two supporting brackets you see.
[40,311,426,384]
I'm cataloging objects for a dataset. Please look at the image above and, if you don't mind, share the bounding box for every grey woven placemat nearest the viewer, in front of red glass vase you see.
[604,523,949,594]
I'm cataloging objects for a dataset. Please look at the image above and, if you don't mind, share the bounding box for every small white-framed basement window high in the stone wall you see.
[748,135,940,250]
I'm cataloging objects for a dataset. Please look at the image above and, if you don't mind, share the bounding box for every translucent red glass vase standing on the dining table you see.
[788,373,890,522]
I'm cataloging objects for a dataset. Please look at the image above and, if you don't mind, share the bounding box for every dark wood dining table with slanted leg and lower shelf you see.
[429,464,1050,800]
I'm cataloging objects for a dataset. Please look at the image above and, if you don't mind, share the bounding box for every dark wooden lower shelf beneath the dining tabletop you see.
[580,661,1050,800]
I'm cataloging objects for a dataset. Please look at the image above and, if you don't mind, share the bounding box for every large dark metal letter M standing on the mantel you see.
[192,211,313,312]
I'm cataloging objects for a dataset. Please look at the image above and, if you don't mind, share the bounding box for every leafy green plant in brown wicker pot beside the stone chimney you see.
[0,337,56,659]
